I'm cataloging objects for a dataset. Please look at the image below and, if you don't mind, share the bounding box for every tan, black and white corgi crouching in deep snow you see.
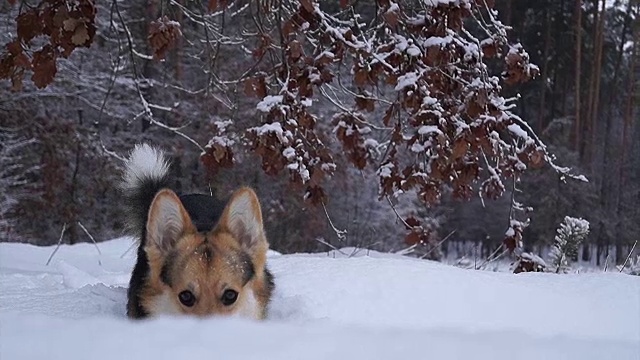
[121,144,274,320]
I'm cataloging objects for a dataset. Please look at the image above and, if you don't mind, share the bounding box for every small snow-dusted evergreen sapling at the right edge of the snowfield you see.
[549,216,589,273]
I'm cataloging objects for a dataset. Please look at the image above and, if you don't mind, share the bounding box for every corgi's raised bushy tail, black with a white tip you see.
[120,144,169,243]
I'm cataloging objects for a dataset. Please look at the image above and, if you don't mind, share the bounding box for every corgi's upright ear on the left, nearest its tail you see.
[147,189,196,252]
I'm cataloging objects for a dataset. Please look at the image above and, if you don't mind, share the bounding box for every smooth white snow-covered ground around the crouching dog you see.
[0,238,640,360]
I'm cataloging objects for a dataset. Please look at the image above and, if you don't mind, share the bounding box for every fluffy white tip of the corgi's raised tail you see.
[122,144,169,189]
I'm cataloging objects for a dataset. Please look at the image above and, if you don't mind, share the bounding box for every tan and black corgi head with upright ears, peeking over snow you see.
[141,188,269,319]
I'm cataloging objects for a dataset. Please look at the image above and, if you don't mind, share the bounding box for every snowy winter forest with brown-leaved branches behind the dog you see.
[0,0,640,272]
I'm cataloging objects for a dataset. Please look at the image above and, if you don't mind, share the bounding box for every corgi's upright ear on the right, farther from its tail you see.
[219,187,269,256]
